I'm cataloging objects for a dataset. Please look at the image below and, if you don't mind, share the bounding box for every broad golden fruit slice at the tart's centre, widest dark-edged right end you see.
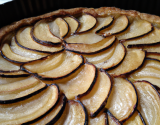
[56,63,97,100]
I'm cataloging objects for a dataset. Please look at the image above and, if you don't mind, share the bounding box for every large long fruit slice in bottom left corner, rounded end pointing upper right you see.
[0,85,59,125]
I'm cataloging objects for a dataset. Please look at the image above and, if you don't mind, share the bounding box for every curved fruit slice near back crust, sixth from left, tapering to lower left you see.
[99,15,129,37]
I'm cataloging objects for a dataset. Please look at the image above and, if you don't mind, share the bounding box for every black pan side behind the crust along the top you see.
[0,0,160,27]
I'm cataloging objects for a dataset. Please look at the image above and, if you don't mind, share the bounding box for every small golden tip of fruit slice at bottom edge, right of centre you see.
[123,111,146,125]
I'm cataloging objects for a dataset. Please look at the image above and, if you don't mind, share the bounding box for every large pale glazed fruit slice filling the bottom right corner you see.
[133,81,160,125]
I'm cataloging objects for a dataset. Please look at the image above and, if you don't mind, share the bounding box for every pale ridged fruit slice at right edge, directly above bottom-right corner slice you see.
[129,60,160,87]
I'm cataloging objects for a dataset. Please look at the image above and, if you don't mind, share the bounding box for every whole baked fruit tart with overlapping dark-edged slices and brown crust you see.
[0,7,160,125]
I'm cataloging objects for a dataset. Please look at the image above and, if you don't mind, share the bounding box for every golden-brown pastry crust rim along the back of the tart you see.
[0,7,160,42]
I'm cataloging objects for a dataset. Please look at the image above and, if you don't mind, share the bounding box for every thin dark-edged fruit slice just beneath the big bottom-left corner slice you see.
[29,94,67,125]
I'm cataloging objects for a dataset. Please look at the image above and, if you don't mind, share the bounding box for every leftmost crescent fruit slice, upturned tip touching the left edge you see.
[1,43,39,63]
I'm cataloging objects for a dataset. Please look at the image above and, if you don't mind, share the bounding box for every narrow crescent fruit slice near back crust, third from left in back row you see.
[63,16,80,35]
